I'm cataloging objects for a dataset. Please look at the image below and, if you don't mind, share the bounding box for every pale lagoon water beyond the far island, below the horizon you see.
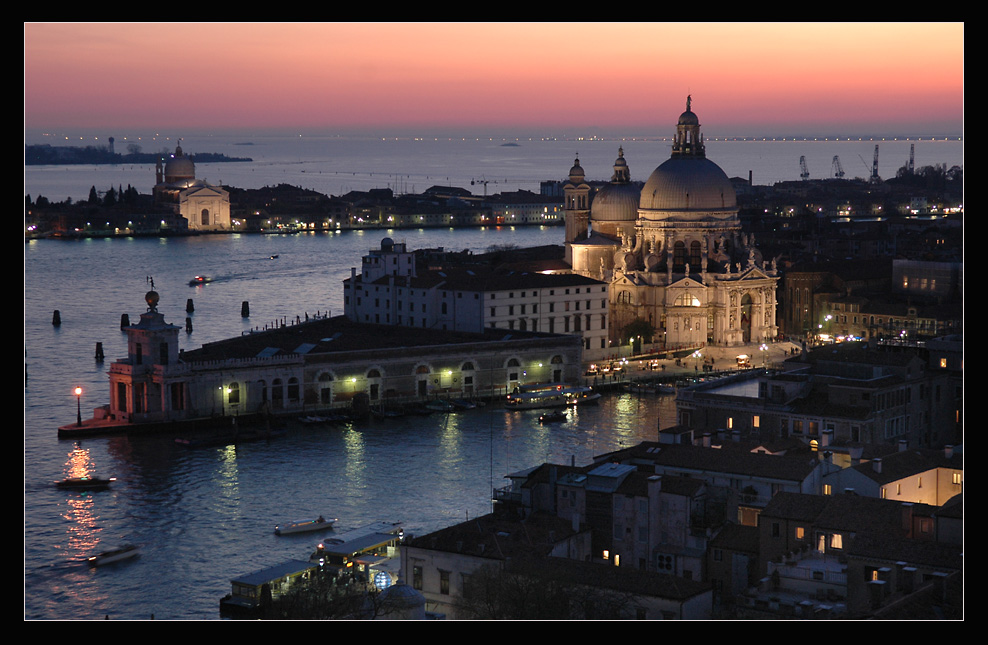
[25,130,964,201]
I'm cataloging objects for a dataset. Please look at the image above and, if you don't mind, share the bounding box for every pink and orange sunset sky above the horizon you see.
[24,22,964,137]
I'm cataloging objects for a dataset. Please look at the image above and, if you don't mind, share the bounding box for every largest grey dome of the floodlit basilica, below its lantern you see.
[641,156,737,211]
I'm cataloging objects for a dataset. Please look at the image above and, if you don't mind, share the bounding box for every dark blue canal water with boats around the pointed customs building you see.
[24,227,675,620]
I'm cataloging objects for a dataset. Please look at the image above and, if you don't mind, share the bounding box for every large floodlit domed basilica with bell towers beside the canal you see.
[563,98,778,348]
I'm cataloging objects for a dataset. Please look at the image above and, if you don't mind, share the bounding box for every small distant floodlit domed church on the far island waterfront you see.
[154,145,231,231]
